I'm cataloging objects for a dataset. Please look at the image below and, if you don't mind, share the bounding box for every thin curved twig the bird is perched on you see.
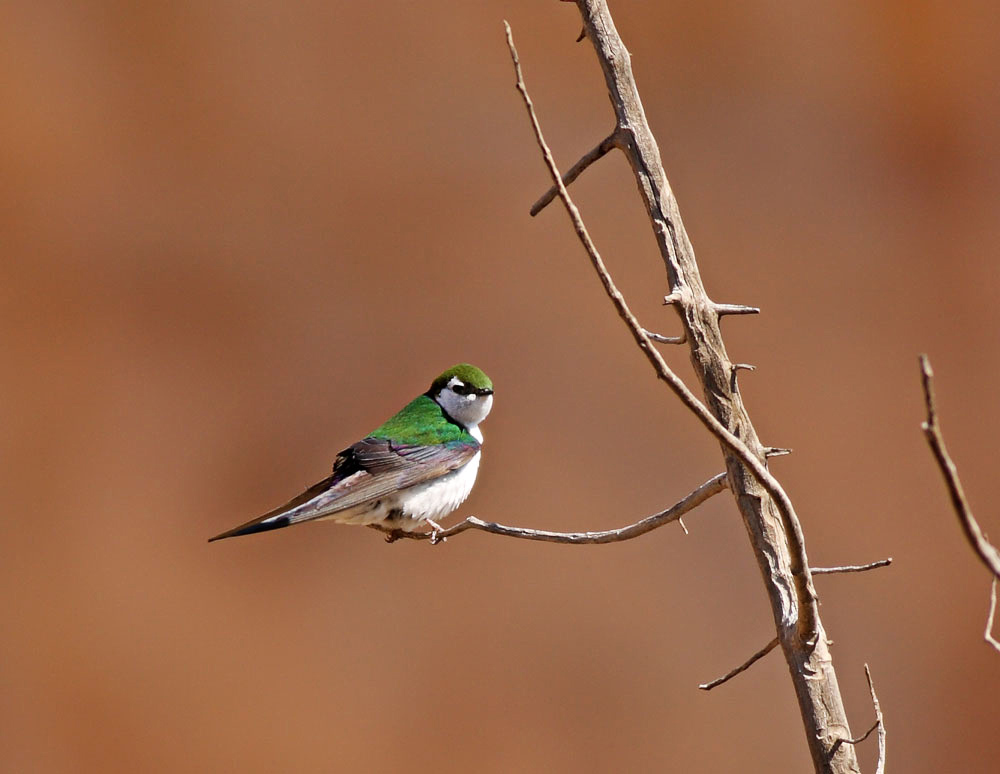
[369,473,728,545]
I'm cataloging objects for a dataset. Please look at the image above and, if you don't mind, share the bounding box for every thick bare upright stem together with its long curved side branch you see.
[524,0,860,774]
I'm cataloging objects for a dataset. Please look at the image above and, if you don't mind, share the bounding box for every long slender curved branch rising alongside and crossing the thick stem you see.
[504,21,818,640]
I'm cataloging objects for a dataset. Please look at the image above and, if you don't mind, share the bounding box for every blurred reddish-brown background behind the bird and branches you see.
[0,0,1000,772]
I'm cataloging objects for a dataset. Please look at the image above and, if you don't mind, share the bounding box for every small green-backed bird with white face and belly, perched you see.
[209,363,493,542]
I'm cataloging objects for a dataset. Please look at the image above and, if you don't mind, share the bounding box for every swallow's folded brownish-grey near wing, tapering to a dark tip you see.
[212,438,479,540]
